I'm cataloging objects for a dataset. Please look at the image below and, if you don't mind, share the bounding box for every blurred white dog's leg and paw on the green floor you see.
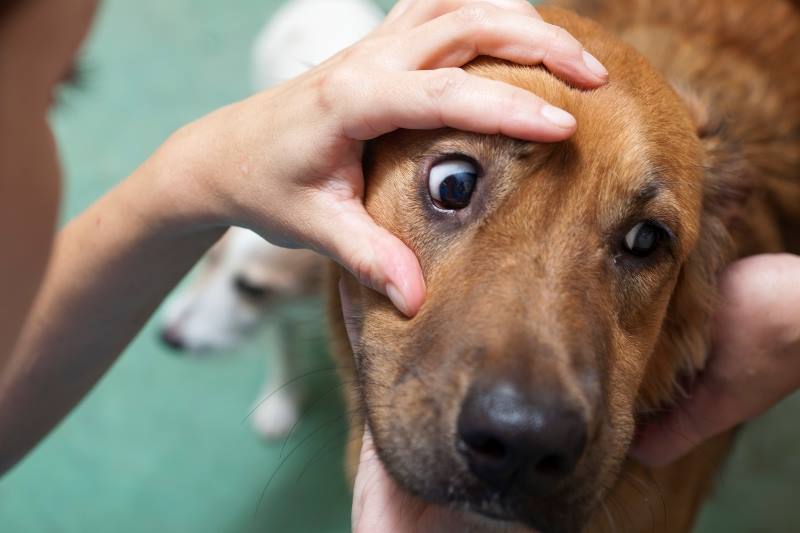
[250,320,304,440]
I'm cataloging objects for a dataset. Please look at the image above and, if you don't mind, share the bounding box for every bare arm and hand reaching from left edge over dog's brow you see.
[0,0,604,471]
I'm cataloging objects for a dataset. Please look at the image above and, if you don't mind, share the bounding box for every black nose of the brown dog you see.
[457,382,586,496]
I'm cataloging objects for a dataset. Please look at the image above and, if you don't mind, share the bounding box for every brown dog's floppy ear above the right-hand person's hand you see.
[638,87,754,414]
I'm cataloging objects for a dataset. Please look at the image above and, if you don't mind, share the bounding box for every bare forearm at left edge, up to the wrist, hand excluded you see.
[0,155,223,472]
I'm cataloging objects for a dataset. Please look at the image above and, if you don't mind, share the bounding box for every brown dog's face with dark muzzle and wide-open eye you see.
[342,9,716,531]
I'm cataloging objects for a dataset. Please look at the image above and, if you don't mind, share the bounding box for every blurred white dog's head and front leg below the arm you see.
[161,228,324,439]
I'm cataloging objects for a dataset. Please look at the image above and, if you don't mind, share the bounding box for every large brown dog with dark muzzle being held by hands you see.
[331,0,800,532]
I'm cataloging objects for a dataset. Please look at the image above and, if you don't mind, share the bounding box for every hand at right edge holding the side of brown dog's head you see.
[632,254,800,466]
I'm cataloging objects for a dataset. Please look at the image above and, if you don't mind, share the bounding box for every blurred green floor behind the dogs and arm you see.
[0,0,800,533]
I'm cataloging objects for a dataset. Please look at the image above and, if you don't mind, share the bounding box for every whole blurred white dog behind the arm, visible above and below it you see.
[161,0,384,439]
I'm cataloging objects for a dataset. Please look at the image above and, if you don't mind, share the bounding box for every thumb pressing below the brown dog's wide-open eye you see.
[320,202,425,317]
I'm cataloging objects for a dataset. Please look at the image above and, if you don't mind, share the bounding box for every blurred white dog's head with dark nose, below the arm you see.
[161,228,321,351]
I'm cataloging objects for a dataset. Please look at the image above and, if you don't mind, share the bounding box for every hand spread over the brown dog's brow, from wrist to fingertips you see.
[160,0,607,316]
